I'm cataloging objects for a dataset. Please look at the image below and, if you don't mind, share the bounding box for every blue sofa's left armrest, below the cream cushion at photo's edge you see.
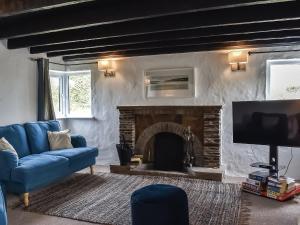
[0,150,19,180]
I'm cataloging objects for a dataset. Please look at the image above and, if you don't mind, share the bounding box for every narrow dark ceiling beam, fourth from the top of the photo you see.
[47,30,300,57]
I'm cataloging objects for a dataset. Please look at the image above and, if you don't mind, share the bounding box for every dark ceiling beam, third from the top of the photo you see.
[30,20,300,54]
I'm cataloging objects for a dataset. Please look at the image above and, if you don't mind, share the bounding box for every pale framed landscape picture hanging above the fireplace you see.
[144,68,195,98]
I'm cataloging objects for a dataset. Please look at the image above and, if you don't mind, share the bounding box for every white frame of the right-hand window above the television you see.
[265,58,300,100]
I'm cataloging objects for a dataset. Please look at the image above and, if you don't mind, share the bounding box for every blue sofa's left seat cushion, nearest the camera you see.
[11,154,69,186]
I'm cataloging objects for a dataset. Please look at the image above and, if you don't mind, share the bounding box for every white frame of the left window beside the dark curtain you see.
[49,70,93,119]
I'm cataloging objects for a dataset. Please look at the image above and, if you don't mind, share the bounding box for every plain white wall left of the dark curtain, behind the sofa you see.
[0,42,37,125]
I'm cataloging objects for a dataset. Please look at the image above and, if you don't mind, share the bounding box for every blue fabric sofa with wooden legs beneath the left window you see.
[0,121,98,207]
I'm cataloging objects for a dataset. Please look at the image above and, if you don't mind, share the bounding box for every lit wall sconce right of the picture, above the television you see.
[228,51,248,71]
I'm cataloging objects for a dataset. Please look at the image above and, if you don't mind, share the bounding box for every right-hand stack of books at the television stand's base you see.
[267,176,296,199]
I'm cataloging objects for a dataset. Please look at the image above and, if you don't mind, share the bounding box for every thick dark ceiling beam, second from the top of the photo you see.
[8,1,300,49]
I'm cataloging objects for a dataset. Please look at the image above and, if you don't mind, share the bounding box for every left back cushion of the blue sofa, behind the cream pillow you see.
[0,124,30,158]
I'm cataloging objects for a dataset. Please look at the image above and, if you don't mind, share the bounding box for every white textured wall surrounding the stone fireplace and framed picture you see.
[66,47,300,179]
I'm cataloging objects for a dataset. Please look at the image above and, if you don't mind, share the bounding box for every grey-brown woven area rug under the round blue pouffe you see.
[17,173,249,225]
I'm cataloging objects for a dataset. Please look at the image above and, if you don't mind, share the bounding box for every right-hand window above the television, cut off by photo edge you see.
[266,59,300,100]
